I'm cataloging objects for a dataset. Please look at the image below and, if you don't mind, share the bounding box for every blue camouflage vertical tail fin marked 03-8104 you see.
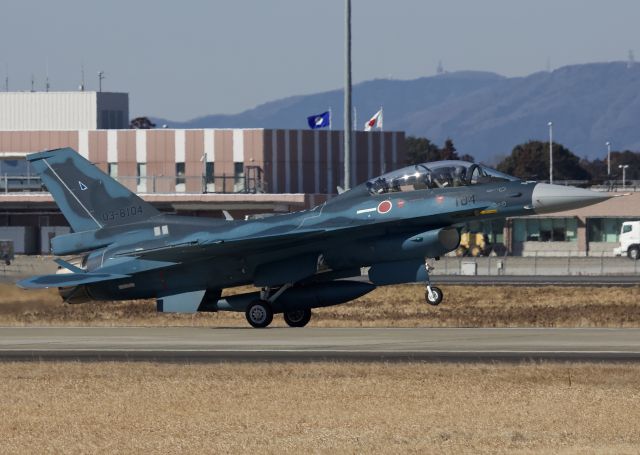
[27,148,159,232]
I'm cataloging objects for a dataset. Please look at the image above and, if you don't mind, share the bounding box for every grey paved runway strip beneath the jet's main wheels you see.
[0,327,640,362]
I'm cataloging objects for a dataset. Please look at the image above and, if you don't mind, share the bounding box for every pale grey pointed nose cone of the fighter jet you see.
[531,183,613,213]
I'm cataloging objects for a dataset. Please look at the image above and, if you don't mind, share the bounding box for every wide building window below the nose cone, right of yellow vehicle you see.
[513,218,578,242]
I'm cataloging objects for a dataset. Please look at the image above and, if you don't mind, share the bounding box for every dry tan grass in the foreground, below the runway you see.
[0,362,640,454]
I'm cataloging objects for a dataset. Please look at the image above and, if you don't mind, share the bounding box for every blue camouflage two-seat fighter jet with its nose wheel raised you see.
[18,148,610,328]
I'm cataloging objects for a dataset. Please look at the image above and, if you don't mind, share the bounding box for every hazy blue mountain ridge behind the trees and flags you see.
[155,62,640,162]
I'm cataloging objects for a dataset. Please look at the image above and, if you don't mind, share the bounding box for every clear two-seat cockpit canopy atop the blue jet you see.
[366,160,518,194]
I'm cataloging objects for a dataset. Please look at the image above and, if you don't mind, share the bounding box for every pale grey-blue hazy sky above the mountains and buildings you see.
[0,0,640,120]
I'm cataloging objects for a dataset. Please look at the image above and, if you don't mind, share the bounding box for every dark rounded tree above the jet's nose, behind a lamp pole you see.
[497,141,591,180]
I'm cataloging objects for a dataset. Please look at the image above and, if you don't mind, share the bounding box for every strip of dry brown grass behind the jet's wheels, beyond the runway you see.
[0,284,640,327]
